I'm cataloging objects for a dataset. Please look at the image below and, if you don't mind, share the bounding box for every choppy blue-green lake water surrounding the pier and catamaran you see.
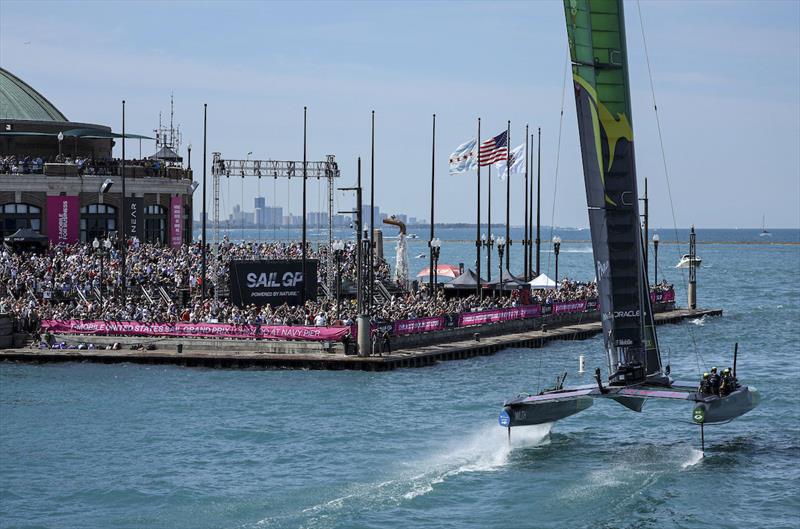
[0,229,800,529]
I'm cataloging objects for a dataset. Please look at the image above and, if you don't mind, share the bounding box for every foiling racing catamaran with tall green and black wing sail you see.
[499,0,760,450]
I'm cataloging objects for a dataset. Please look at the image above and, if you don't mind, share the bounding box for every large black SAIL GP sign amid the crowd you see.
[230,259,317,307]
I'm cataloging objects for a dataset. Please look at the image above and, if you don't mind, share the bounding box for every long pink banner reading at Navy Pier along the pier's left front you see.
[42,320,350,342]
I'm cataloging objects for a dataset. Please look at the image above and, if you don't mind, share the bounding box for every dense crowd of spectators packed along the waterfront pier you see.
[0,238,669,330]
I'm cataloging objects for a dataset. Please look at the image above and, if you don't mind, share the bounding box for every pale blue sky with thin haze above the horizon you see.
[0,0,800,228]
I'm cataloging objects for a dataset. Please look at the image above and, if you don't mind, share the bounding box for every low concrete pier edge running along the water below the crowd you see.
[0,309,722,371]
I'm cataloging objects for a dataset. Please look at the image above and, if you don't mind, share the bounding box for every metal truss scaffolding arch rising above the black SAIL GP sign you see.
[211,152,341,298]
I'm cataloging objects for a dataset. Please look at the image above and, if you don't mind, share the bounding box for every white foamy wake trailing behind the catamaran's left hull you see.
[256,424,552,527]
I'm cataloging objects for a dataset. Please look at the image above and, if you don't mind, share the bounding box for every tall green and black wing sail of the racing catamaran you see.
[564,0,668,385]
